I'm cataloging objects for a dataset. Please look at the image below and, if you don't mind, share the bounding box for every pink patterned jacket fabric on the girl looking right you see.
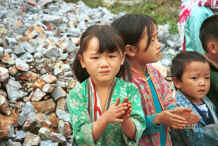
[127,65,176,146]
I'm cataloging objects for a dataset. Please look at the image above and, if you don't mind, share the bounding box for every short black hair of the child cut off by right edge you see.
[200,15,218,52]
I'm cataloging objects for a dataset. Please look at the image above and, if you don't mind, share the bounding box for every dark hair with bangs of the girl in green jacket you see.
[73,25,125,82]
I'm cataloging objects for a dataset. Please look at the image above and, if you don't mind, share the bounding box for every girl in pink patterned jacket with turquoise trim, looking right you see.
[112,14,195,146]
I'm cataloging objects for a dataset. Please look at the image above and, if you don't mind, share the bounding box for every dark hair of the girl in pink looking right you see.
[111,14,157,50]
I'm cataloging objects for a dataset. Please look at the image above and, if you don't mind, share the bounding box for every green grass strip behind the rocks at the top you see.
[65,0,180,34]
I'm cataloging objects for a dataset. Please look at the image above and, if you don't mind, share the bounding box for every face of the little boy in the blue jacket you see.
[175,61,210,102]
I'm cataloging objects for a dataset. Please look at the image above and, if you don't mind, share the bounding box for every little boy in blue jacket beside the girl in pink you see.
[171,52,218,146]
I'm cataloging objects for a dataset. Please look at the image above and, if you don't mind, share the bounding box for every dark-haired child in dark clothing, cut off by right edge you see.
[200,15,218,113]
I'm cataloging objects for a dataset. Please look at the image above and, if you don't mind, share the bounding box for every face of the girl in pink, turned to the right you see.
[135,25,162,64]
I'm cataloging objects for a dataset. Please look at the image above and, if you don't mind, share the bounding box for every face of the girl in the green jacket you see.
[79,37,125,83]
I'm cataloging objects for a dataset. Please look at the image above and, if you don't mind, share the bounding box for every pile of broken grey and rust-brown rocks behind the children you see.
[0,0,179,146]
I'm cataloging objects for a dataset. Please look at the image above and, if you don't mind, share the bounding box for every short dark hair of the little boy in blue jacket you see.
[171,51,208,81]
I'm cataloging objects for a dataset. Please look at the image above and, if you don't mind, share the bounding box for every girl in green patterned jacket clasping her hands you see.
[67,25,145,146]
